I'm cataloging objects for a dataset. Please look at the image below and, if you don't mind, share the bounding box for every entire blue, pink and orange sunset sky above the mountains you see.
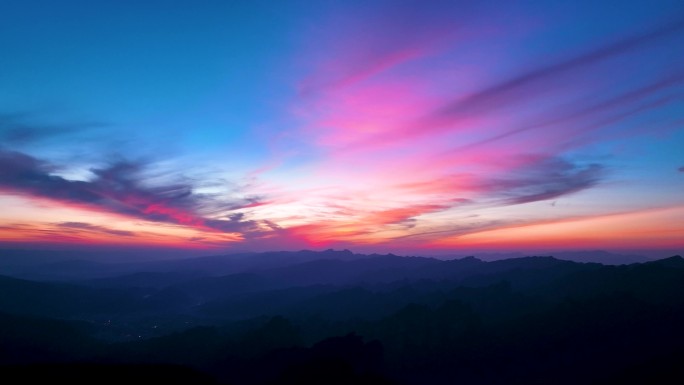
[0,0,684,254]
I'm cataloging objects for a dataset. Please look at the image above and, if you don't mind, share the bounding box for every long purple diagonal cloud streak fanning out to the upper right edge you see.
[351,20,684,148]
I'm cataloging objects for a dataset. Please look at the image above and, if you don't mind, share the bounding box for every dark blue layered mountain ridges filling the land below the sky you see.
[0,251,684,385]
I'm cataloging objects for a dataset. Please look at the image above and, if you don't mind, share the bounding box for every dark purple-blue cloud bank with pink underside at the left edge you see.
[0,151,264,233]
